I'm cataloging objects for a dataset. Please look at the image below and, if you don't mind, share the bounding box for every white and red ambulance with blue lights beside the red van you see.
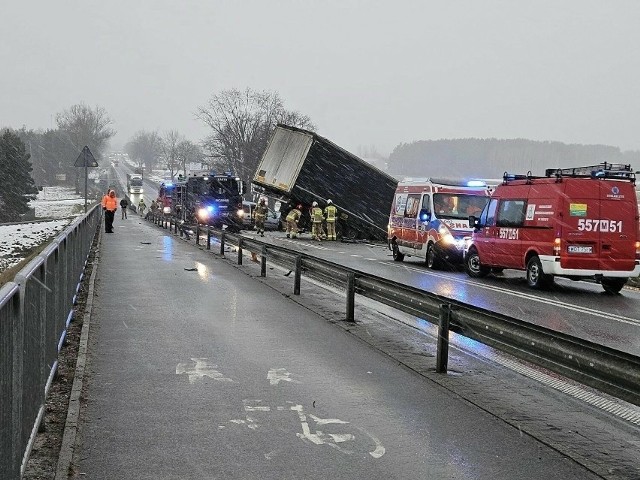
[387,178,489,269]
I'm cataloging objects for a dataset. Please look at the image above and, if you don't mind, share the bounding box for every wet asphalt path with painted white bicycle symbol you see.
[57,215,637,480]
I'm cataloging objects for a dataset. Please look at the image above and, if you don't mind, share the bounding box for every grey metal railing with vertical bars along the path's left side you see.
[0,206,102,480]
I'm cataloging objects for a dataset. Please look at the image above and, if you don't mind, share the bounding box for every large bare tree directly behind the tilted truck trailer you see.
[196,88,315,178]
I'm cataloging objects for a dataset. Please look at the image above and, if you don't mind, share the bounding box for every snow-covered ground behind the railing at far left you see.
[0,187,84,272]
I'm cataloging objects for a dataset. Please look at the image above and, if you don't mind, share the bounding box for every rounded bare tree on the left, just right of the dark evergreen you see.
[56,103,116,156]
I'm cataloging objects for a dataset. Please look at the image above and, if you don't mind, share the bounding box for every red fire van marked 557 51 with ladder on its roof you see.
[464,163,640,293]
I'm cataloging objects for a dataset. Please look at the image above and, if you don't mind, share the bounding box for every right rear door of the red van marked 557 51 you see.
[599,181,638,271]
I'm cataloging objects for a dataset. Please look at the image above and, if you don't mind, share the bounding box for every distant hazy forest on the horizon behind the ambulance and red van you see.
[388,138,640,179]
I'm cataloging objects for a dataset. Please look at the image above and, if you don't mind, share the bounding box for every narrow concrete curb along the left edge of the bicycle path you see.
[54,230,103,480]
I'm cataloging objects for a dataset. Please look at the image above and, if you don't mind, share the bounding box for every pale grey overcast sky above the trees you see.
[0,0,640,154]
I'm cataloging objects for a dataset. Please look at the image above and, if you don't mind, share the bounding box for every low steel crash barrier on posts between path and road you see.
[150,215,640,405]
